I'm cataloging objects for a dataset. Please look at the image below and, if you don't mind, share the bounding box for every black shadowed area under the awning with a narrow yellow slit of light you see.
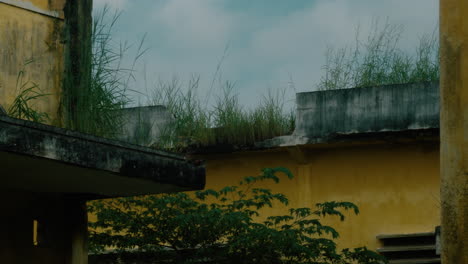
[0,192,69,264]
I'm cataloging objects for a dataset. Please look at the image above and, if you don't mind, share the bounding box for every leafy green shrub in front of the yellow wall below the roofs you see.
[89,167,385,264]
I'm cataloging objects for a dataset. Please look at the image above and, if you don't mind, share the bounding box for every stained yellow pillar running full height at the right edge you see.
[440,0,468,264]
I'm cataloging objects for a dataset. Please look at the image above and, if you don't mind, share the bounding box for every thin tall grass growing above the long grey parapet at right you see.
[317,20,439,90]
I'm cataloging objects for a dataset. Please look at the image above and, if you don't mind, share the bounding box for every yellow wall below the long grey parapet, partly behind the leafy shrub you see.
[199,142,440,249]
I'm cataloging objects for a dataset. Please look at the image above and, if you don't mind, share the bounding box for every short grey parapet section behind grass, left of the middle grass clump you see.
[119,106,173,146]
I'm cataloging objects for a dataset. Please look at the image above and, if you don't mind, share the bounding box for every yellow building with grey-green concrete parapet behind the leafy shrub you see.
[118,83,440,263]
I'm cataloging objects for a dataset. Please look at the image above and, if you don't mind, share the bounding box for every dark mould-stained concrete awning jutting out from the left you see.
[0,114,205,199]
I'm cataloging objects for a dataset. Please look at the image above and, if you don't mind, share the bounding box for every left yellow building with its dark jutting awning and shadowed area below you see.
[0,0,205,264]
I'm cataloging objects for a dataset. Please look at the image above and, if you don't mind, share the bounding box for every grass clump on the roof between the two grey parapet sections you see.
[151,76,294,151]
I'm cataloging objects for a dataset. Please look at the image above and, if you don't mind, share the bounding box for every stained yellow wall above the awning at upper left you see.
[0,0,65,123]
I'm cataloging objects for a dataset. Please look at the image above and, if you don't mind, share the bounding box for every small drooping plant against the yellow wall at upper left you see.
[8,60,49,123]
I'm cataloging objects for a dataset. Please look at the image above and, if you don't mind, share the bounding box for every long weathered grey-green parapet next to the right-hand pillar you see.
[293,83,439,143]
